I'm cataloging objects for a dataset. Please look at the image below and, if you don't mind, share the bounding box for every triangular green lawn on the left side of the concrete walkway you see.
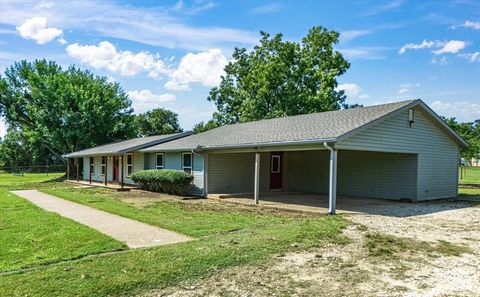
[0,187,126,272]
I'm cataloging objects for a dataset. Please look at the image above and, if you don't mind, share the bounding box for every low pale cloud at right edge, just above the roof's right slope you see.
[430,100,480,122]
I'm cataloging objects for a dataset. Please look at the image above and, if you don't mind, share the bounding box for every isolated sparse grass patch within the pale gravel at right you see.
[365,233,472,258]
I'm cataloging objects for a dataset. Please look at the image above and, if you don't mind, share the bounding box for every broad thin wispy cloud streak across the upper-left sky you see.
[0,0,258,50]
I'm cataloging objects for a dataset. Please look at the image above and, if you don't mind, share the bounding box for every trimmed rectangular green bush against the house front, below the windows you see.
[131,169,193,196]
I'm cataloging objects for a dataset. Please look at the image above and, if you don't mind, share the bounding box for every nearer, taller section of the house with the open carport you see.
[63,100,467,213]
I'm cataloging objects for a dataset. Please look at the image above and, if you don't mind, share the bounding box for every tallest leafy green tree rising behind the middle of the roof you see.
[207,27,350,125]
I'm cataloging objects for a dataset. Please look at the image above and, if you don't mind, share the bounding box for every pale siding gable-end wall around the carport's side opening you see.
[337,108,459,200]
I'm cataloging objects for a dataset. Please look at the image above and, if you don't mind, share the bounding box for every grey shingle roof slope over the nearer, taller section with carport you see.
[141,100,420,152]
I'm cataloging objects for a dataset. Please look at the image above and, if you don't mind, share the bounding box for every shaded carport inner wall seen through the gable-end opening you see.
[338,150,417,200]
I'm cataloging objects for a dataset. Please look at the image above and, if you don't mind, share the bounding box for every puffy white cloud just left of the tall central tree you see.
[164,49,227,91]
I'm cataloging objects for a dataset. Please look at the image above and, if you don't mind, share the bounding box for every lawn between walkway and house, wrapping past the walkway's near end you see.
[0,176,348,296]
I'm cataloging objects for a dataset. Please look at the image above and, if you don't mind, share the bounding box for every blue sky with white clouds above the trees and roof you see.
[0,0,480,136]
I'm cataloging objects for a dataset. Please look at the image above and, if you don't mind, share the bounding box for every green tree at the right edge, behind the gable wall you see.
[443,118,480,160]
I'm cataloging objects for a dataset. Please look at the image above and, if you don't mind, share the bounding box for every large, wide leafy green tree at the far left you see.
[0,60,135,160]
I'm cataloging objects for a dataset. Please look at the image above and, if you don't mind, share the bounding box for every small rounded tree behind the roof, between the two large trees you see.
[135,108,183,136]
